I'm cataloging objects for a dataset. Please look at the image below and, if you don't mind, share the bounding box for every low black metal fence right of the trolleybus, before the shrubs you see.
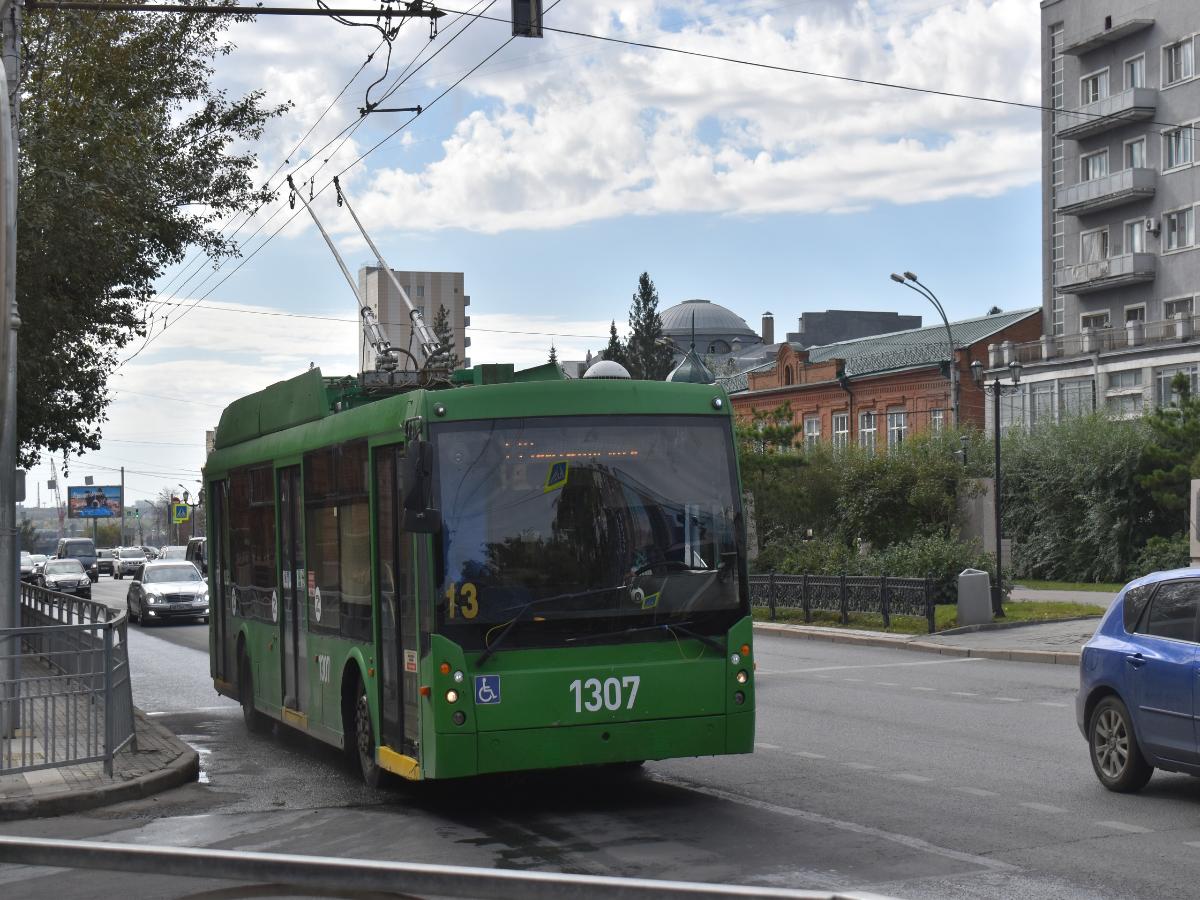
[750,572,936,634]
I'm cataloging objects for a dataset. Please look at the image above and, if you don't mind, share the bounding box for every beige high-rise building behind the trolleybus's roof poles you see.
[359,265,470,372]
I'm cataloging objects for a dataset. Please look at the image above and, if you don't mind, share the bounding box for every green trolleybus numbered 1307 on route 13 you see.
[204,365,754,784]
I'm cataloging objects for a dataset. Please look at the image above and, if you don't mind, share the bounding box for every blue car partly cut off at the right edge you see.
[1075,569,1200,793]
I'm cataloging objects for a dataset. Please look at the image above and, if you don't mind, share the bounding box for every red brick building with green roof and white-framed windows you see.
[721,308,1042,448]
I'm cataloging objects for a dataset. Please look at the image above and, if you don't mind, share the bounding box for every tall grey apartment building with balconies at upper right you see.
[1003,0,1200,425]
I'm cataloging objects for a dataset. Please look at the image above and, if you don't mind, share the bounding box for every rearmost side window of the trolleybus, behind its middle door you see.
[229,466,276,622]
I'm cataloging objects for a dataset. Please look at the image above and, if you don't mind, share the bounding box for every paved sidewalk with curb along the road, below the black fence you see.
[754,618,1099,666]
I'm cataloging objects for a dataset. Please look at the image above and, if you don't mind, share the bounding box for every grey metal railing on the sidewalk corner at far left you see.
[0,584,134,775]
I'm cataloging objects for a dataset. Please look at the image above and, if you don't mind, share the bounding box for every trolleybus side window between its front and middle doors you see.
[304,440,371,641]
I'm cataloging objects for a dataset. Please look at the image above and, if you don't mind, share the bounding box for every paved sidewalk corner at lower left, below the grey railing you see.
[0,709,200,821]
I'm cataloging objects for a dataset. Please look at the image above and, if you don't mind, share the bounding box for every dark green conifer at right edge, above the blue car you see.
[1138,372,1200,538]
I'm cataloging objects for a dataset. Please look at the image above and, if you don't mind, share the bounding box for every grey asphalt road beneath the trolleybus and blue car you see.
[0,609,1200,900]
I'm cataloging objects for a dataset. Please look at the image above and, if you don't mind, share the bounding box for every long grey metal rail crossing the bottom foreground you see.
[0,836,887,900]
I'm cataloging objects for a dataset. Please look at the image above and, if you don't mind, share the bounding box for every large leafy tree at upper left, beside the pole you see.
[17,7,287,467]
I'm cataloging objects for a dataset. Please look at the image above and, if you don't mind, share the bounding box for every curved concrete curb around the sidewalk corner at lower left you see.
[0,707,200,821]
